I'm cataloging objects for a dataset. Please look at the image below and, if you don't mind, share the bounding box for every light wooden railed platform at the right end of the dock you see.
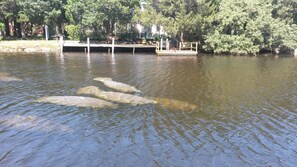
[156,42,198,56]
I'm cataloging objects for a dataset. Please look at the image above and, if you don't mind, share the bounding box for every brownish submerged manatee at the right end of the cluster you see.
[152,97,198,111]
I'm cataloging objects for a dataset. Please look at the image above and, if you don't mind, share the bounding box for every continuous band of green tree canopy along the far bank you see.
[0,0,297,54]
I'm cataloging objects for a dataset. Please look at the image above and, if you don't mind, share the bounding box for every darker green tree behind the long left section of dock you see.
[65,0,139,39]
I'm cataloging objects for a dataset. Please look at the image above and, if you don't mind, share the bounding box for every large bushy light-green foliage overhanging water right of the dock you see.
[204,0,297,54]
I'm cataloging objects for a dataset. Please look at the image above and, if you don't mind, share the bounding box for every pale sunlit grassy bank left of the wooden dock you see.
[0,40,59,52]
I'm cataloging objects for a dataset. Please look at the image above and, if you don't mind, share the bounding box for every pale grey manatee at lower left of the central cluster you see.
[36,96,117,108]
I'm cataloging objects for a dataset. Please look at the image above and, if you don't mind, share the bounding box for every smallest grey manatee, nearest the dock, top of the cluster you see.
[94,77,141,93]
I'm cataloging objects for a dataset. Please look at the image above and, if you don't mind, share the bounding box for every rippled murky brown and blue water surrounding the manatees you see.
[0,53,297,167]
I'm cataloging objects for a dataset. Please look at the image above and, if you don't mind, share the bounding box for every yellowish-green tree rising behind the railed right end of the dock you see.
[133,0,219,42]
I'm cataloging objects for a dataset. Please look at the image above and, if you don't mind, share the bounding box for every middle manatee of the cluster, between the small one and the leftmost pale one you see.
[77,86,156,106]
